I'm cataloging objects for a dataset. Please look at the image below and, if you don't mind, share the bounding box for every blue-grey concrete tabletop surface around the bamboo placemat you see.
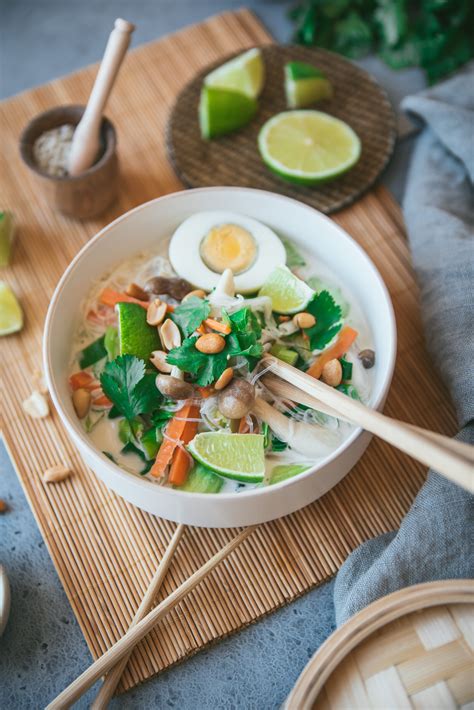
[0,0,424,710]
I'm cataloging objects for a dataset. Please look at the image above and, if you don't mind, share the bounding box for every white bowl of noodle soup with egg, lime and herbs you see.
[43,187,396,527]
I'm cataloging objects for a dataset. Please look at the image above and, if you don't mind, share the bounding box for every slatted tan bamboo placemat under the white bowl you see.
[0,10,455,690]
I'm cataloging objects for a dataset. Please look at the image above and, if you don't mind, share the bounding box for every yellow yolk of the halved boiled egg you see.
[201,224,257,274]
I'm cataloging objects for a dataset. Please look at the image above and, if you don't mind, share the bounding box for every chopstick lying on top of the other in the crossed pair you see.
[47,525,258,710]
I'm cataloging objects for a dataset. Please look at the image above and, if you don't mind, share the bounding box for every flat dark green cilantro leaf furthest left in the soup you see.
[100,355,161,421]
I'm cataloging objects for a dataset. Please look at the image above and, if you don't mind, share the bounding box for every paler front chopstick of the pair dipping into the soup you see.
[264,356,474,491]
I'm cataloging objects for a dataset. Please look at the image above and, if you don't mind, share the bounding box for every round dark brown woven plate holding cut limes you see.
[167,45,396,214]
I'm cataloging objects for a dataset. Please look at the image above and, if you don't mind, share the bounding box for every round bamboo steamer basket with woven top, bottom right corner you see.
[285,580,474,710]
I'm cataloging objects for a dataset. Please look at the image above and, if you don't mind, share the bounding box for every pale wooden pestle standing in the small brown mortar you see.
[68,18,135,175]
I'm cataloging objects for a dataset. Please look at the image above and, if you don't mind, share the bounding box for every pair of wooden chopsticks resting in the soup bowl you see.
[262,355,474,492]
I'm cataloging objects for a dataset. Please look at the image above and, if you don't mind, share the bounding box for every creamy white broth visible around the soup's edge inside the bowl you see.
[69,236,373,493]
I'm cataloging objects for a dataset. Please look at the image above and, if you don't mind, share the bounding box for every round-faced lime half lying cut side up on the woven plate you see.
[258,111,361,185]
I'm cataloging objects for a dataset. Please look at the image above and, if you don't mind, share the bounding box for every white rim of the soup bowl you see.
[43,186,397,500]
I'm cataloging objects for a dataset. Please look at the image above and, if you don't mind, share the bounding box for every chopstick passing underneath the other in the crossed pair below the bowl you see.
[91,524,185,710]
